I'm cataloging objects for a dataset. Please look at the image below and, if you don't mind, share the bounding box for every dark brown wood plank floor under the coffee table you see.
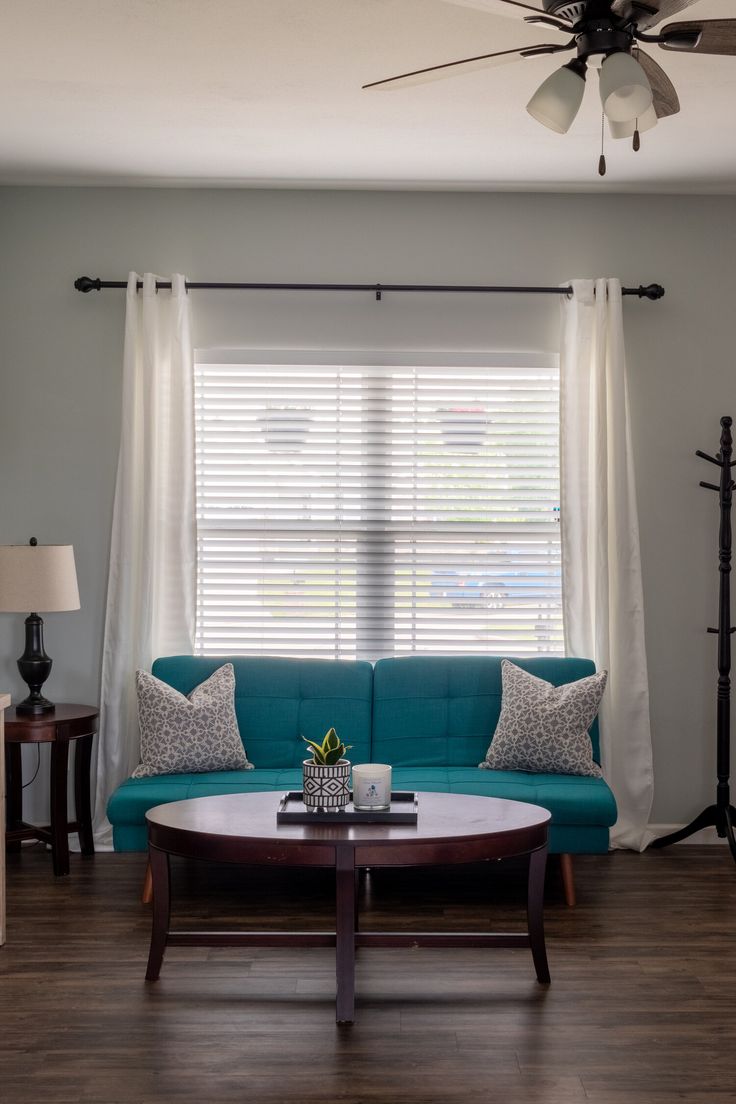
[0,846,736,1104]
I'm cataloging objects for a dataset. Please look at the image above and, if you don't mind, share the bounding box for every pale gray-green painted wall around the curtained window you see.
[0,188,736,822]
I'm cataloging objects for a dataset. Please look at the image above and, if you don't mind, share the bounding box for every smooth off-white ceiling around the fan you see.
[0,0,736,192]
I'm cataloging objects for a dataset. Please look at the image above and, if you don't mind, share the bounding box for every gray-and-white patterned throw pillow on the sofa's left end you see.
[132,664,253,778]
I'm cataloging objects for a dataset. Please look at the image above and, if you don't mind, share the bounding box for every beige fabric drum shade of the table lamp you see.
[0,544,79,614]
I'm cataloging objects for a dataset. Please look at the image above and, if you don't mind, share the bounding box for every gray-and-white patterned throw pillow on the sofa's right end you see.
[479,659,608,778]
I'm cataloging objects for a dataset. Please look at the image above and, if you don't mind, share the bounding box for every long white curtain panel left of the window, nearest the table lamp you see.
[95,273,196,849]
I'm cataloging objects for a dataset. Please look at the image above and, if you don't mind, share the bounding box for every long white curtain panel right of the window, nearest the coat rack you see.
[559,279,653,850]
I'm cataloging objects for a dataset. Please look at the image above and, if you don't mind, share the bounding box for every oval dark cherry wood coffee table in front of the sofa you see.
[146,793,551,1023]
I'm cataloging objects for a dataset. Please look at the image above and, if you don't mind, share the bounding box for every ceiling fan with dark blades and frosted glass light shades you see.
[363,0,736,176]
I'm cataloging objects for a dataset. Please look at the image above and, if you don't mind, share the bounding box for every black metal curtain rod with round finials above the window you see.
[74,276,664,299]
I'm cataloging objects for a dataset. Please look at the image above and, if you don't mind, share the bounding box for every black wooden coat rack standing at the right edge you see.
[651,417,736,861]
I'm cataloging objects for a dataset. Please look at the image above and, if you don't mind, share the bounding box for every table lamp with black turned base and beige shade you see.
[0,537,79,714]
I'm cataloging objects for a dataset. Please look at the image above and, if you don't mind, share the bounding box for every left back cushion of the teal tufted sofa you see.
[152,656,373,769]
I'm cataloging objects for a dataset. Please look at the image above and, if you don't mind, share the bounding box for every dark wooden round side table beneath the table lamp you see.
[6,704,99,877]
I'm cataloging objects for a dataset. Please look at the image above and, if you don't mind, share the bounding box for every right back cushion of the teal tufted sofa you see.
[373,656,600,766]
